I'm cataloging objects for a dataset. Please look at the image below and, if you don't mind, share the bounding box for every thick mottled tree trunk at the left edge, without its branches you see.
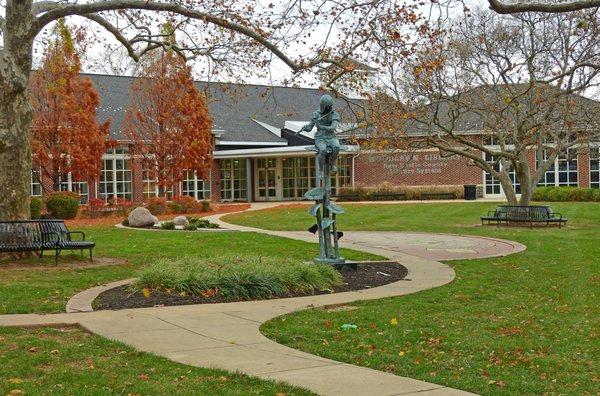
[0,0,33,220]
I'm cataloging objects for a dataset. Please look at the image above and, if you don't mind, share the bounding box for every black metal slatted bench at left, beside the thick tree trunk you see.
[0,220,95,263]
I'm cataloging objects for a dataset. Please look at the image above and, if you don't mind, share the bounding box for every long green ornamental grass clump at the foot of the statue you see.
[134,256,342,300]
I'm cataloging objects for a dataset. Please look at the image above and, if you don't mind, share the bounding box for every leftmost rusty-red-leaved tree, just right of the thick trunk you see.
[30,20,109,191]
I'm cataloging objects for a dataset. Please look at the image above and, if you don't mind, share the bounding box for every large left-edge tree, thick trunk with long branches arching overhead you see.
[0,0,422,219]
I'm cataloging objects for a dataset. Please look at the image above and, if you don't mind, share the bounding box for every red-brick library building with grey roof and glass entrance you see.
[31,75,600,202]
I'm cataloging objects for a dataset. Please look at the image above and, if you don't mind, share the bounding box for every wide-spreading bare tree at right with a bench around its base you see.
[370,11,600,205]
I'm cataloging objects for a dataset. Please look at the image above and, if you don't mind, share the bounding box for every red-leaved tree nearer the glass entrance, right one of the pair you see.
[124,37,212,197]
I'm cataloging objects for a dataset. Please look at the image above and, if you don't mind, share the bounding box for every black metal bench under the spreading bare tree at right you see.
[481,205,567,228]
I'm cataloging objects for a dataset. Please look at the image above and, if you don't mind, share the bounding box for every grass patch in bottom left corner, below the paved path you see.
[0,327,312,395]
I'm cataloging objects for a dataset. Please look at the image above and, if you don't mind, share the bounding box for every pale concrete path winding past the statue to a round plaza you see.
[0,205,524,396]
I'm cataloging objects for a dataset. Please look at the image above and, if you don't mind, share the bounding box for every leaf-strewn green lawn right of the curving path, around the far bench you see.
[226,202,600,395]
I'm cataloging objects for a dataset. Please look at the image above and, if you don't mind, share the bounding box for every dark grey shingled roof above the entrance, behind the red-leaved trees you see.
[85,74,353,143]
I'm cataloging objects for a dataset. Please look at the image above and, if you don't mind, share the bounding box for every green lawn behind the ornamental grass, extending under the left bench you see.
[0,225,374,314]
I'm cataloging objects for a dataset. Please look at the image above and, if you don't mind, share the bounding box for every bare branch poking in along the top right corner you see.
[488,0,600,14]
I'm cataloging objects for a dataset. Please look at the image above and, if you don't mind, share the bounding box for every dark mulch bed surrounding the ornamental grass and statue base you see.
[93,261,408,310]
